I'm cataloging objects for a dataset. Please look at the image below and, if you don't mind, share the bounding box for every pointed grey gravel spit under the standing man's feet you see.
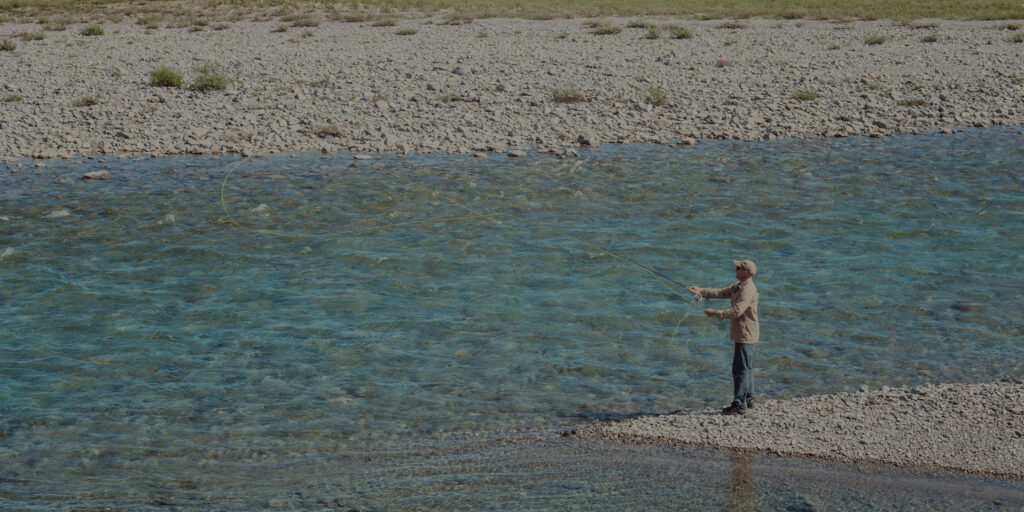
[570,380,1024,479]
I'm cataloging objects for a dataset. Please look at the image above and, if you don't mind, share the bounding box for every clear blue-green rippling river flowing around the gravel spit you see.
[0,129,1024,510]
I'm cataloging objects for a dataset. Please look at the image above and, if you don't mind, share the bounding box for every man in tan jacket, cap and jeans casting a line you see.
[686,259,760,415]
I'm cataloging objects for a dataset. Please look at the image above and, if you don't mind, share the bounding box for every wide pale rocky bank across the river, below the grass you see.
[0,17,1024,161]
